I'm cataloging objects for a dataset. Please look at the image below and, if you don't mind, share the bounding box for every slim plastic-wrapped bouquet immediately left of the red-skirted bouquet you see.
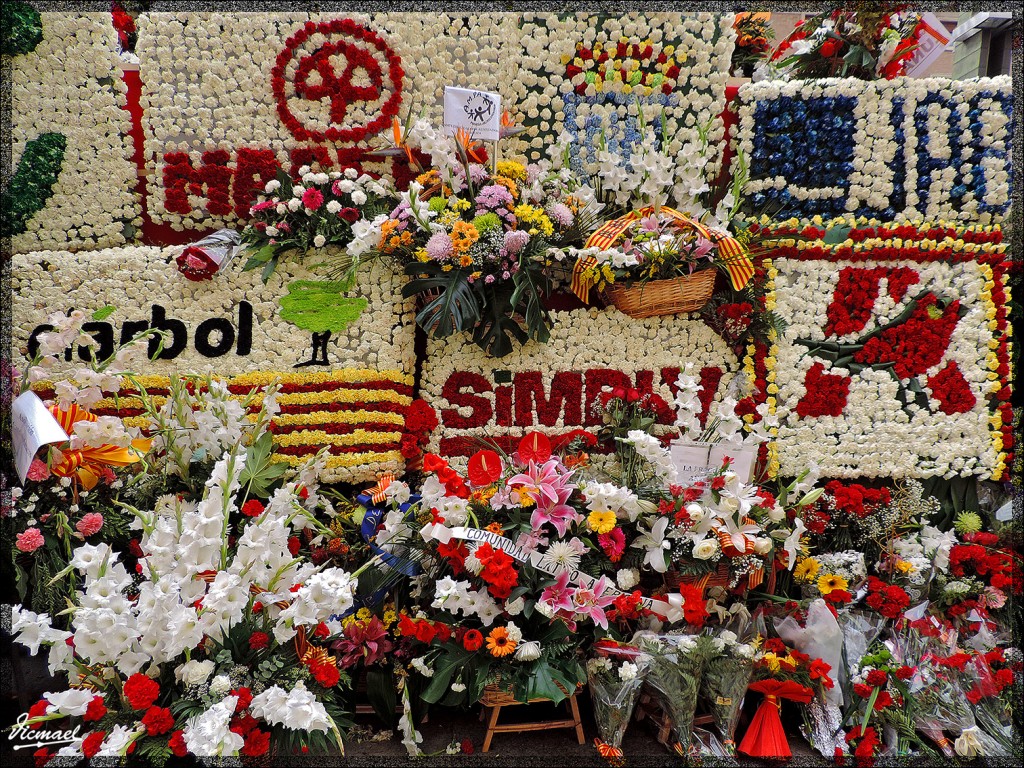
[700,632,756,755]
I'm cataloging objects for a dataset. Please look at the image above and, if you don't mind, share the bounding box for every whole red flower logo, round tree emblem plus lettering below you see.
[162,18,411,219]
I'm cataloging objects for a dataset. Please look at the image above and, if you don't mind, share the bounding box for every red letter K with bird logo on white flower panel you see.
[796,266,977,419]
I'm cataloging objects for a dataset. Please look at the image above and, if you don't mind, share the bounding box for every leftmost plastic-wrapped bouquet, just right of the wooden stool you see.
[587,640,651,761]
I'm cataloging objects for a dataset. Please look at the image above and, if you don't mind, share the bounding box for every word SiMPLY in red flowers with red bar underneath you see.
[437,366,724,457]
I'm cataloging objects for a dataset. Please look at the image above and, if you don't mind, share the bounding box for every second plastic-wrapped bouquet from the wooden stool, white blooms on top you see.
[636,632,713,755]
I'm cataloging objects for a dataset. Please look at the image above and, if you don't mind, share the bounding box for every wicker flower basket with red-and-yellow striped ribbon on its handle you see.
[572,206,753,319]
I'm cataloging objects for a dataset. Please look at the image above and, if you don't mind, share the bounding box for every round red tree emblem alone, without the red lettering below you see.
[270,18,406,142]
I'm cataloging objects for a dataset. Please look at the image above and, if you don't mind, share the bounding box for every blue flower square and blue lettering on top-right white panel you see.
[748,84,1013,220]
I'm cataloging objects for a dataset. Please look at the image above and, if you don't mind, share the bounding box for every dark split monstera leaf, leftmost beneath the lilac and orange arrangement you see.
[401,262,480,339]
